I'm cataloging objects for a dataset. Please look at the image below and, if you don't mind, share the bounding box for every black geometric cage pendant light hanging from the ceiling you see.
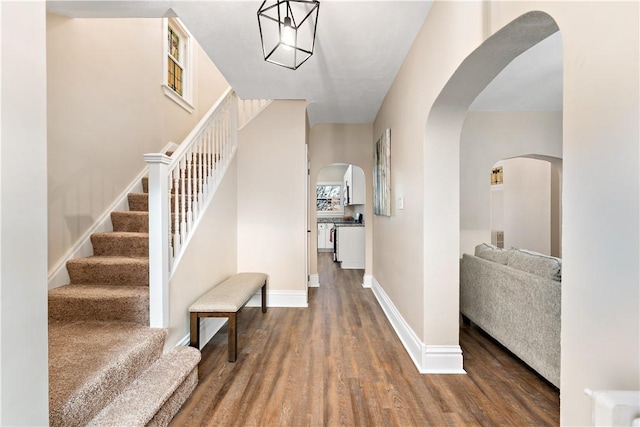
[258,0,320,70]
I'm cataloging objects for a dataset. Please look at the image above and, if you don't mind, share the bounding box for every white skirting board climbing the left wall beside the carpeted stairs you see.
[47,142,178,289]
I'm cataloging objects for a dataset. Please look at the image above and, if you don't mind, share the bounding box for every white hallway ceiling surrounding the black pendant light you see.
[176,1,430,125]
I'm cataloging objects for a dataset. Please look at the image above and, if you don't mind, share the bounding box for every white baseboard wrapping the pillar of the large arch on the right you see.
[371,276,466,374]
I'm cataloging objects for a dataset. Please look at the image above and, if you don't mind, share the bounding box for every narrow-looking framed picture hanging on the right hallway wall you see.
[373,129,391,216]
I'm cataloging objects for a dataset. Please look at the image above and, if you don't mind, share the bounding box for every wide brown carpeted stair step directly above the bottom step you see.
[49,322,167,427]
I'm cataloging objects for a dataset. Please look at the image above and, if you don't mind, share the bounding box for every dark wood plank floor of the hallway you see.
[171,254,560,426]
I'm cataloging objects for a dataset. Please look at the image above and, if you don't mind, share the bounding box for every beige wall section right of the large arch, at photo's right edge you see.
[528,2,640,425]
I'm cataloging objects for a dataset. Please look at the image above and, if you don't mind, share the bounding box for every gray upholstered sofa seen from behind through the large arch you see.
[460,244,562,387]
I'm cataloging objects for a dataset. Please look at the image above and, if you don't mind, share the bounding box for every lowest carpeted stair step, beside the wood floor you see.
[88,347,200,427]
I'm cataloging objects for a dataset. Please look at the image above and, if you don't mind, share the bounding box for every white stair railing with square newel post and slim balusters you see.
[144,89,239,328]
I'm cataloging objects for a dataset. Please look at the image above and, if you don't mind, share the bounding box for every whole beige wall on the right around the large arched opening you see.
[373,1,640,425]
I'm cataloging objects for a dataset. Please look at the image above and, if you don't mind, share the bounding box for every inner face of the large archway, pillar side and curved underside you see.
[423,12,558,372]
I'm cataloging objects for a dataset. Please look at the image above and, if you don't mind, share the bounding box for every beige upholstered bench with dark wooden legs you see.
[189,273,267,362]
